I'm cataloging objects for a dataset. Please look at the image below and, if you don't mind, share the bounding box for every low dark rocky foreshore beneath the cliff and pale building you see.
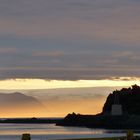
[57,113,140,129]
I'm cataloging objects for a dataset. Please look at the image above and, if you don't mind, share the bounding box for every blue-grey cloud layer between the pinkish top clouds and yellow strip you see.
[0,44,140,80]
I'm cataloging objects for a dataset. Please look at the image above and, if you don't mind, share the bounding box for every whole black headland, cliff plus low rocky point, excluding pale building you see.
[57,85,140,129]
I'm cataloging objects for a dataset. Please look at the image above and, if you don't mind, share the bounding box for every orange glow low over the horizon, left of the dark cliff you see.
[0,99,105,118]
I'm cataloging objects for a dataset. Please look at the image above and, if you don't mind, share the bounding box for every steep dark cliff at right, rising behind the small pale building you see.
[102,85,140,115]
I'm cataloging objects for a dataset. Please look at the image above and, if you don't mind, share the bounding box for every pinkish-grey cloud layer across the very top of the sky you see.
[0,0,140,44]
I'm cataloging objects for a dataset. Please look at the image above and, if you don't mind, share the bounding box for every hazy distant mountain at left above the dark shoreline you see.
[0,92,46,117]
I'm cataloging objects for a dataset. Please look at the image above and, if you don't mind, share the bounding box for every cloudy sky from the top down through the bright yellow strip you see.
[0,0,140,117]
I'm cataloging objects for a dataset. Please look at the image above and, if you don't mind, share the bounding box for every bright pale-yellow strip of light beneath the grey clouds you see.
[0,78,140,90]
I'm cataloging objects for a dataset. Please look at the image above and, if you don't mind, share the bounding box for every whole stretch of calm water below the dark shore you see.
[0,124,137,140]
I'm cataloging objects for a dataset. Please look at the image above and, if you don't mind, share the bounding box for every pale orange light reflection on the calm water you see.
[0,124,107,135]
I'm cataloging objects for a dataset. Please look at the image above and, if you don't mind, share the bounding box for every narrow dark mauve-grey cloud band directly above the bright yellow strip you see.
[0,67,140,80]
